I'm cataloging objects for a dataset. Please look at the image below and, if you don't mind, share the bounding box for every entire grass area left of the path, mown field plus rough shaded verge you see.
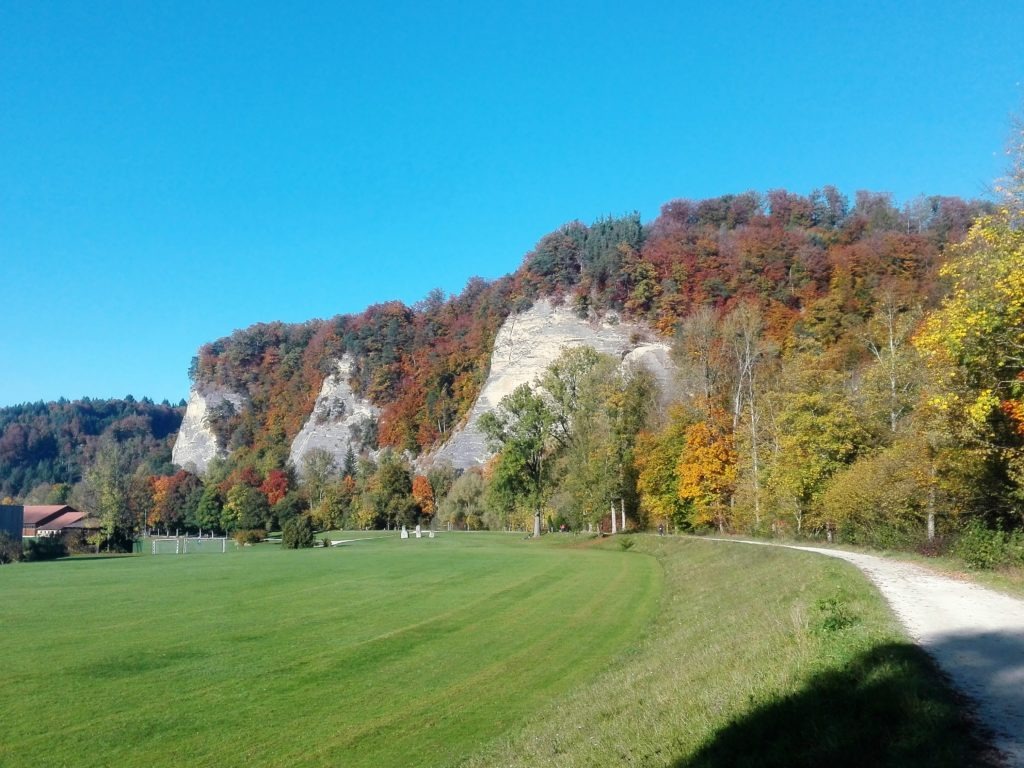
[0,534,980,768]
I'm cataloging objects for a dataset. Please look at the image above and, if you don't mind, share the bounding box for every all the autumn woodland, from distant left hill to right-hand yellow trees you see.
[0,159,1024,566]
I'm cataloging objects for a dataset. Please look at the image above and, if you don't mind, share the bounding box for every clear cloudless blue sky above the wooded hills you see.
[0,0,1024,406]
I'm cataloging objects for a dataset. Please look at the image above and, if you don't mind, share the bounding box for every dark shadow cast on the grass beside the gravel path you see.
[676,644,998,768]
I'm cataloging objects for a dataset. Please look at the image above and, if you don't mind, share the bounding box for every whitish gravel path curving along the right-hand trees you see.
[723,540,1024,768]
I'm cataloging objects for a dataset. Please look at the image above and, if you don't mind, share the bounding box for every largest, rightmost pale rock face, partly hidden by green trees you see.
[424,299,673,469]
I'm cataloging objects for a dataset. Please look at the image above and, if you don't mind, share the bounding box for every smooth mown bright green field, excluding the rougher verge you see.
[0,535,662,766]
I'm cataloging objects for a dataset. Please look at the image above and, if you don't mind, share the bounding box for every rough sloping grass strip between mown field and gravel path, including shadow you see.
[468,537,988,768]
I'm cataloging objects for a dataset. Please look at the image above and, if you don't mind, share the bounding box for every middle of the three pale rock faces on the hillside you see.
[289,354,380,475]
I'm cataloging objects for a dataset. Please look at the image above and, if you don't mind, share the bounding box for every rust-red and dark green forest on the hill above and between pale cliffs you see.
[191,187,985,464]
